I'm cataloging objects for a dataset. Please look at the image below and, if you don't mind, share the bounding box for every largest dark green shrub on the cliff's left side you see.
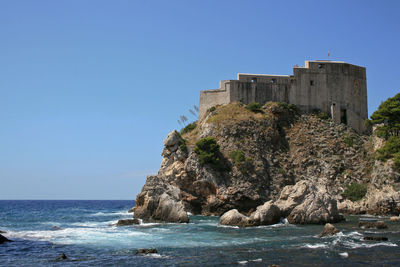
[194,137,222,169]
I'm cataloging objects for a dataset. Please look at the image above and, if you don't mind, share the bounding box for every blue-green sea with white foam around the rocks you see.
[0,200,400,267]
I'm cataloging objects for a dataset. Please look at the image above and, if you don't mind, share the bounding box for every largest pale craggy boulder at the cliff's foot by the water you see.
[275,180,344,224]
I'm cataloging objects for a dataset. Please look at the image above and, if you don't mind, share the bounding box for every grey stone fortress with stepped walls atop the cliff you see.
[199,60,368,133]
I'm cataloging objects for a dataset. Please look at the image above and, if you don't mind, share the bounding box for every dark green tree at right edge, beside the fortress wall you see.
[370,93,400,140]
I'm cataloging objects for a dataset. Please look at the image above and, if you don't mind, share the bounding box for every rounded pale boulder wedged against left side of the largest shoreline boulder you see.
[250,201,281,226]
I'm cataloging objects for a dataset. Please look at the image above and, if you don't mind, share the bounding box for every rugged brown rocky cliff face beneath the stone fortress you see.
[135,103,400,222]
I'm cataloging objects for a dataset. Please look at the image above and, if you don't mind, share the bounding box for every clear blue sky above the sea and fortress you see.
[0,0,400,200]
